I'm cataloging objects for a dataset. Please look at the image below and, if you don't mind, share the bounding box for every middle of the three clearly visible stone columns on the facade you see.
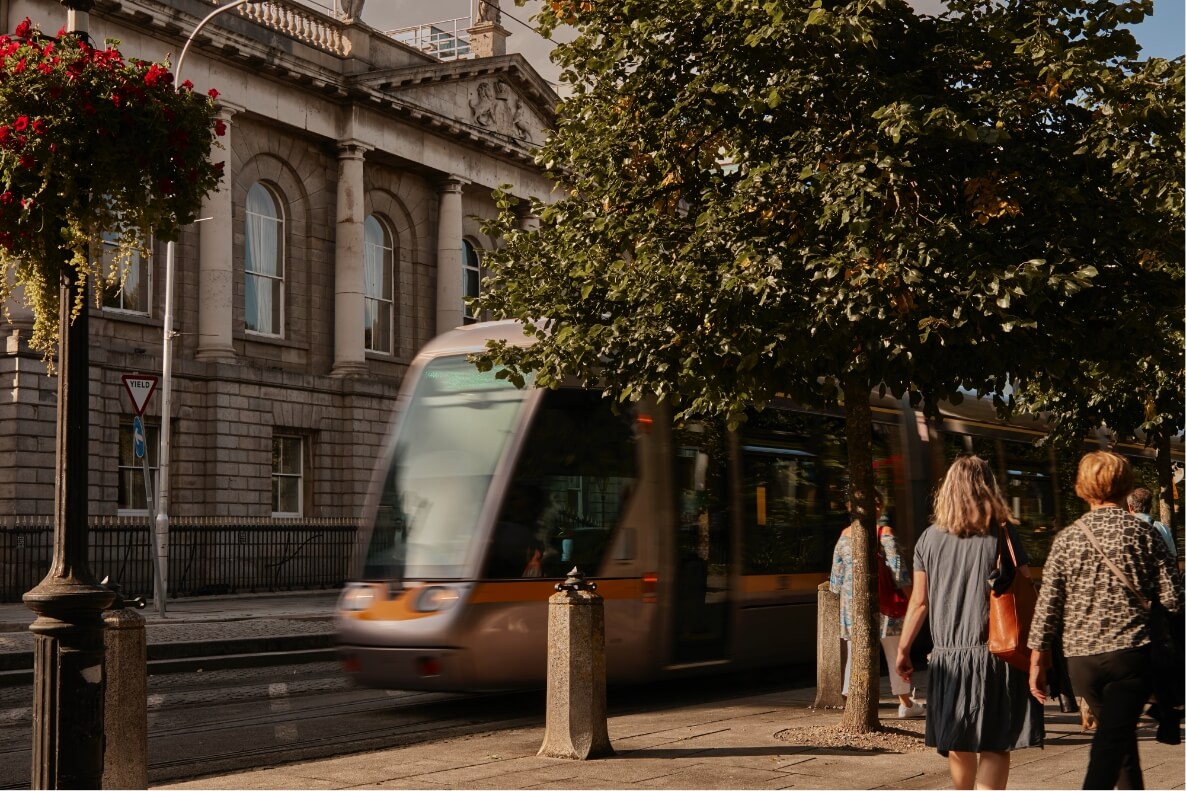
[332,140,371,376]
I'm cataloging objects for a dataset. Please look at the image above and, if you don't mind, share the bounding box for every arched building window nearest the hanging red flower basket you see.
[243,181,285,337]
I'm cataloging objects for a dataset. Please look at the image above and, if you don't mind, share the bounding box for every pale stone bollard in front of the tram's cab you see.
[538,568,613,760]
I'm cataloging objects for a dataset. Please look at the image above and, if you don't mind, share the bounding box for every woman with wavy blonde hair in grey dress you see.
[897,457,1045,789]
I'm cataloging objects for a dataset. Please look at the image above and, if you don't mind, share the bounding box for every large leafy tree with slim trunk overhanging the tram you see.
[476,0,1181,731]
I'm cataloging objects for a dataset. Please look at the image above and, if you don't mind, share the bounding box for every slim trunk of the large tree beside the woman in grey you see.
[840,377,881,733]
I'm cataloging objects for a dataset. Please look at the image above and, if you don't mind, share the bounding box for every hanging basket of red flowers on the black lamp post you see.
[0,19,225,355]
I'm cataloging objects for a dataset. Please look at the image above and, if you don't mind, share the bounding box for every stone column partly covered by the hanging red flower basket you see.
[196,103,243,362]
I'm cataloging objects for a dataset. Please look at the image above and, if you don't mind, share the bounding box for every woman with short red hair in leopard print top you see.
[1029,451,1182,789]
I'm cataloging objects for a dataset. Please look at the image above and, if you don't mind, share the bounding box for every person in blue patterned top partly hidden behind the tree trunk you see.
[828,491,925,720]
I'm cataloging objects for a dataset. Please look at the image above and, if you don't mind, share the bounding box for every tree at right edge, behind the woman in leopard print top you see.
[1014,58,1186,524]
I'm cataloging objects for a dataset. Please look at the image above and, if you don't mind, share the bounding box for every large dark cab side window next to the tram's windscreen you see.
[485,389,637,579]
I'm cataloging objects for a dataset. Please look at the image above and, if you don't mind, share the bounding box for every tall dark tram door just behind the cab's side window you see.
[671,436,732,664]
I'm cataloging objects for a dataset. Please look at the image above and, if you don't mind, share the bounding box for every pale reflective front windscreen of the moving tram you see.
[363,356,528,579]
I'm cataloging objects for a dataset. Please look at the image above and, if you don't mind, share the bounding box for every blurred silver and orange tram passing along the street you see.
[336,321,1176,691]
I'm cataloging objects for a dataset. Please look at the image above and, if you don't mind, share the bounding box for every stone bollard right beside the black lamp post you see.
[103,586,148,789]
